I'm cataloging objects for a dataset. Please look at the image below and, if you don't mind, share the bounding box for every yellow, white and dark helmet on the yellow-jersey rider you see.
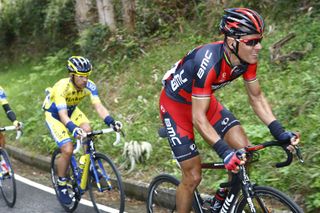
[67,56,92,76]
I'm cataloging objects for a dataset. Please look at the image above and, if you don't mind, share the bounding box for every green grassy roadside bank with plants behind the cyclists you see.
[0,0,320,212]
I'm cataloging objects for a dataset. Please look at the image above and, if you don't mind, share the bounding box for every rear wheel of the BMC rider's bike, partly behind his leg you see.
[146,174,202,213]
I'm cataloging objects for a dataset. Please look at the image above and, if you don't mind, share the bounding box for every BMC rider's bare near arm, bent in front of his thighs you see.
[192,96,220,145]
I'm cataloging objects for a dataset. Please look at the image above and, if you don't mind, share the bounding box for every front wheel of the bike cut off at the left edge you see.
[0,149,17,208]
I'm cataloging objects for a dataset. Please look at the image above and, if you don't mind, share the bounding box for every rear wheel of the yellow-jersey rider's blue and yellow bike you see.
[50,149,80,212]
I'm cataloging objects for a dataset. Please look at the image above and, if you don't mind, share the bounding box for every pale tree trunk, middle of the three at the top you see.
[97,0,116,32]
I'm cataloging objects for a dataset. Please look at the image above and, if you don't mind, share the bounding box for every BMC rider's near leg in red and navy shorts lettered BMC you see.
[160,90,201,212]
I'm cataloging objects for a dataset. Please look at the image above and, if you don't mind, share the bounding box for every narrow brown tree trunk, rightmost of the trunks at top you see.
[121,0,136,32]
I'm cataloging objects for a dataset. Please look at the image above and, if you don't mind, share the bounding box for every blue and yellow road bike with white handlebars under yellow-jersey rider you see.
[51,128,125,212]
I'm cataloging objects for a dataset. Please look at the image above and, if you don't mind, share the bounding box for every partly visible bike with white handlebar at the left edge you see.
[0,126,22,208]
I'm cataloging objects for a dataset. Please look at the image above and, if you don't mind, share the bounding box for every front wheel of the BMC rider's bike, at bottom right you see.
[234,186,303,213]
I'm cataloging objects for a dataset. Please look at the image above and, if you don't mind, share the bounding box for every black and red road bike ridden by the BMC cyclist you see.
[147,129,303,213]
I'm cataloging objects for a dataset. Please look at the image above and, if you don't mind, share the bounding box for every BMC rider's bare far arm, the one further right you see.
[245,80,276,125]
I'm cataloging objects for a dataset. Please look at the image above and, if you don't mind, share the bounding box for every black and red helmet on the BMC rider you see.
[220,8,264,37]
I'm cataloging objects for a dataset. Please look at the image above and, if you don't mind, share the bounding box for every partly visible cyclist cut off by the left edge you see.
[0,86,22,147]
